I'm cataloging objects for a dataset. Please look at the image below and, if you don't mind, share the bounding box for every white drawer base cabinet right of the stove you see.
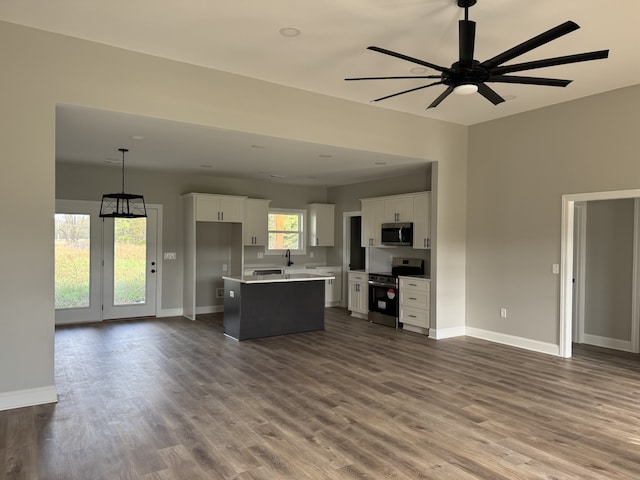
[399,277,431,334]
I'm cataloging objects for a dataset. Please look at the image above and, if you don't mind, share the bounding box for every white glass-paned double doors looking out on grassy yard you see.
[54,201,158,324]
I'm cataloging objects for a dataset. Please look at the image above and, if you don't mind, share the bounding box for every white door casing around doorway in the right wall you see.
[558,189,640,358]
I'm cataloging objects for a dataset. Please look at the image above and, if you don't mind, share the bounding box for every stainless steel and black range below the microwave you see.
[369,257,424,328]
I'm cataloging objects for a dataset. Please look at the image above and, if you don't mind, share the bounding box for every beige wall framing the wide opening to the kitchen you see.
[0,22,467,409]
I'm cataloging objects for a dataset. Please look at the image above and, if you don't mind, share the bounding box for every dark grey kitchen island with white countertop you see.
[222,273,335,340]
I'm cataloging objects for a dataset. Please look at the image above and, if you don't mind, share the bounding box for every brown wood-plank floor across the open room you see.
[0,308,640,480]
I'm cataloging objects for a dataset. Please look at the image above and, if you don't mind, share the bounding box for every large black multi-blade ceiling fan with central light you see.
[345,0,609,108]
